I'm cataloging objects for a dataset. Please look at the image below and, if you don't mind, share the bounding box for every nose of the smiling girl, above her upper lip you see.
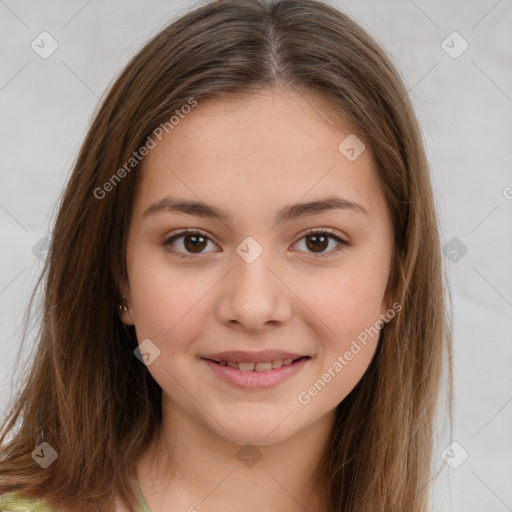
[216,246,293,333]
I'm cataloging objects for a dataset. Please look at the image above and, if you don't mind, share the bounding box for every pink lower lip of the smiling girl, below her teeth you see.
[203,357,309,389]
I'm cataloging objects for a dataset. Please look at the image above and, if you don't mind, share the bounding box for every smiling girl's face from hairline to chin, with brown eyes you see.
[121,91,393,445]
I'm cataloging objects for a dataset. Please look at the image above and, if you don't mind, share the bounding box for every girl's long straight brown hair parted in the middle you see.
[0,0,452,512]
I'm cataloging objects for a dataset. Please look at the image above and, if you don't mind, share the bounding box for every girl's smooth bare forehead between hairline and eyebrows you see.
[134,90,382,221]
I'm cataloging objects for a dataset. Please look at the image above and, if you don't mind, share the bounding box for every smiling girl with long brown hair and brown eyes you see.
[0,0,452,512]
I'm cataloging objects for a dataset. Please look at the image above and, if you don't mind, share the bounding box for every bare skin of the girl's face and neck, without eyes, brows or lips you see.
[120,90,393,512]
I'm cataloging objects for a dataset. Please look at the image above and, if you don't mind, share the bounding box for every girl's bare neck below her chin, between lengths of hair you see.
[137,396,334,512]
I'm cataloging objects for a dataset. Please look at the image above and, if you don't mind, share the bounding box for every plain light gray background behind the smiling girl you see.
[0,0,512,512]
